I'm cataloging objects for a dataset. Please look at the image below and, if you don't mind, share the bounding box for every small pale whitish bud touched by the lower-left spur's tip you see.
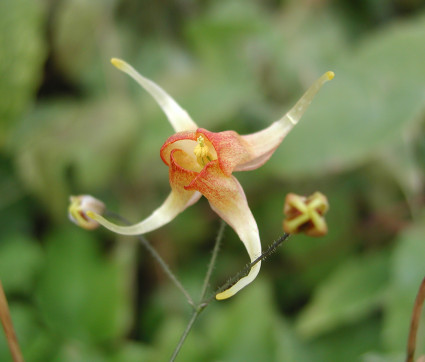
[68,195,105,230]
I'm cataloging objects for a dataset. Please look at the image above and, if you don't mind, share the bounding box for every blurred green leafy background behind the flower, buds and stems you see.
[0,0,425,362]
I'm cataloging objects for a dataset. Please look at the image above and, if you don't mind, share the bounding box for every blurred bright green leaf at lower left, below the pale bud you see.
[37,228,129,343]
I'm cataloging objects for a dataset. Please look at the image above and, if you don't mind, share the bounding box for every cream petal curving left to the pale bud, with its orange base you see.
[87,150,202,235]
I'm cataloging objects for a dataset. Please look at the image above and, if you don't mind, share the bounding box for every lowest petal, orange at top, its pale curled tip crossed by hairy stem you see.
[185,160,261,300]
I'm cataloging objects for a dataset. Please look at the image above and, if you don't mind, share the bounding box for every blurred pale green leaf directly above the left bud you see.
[13,98,136,219]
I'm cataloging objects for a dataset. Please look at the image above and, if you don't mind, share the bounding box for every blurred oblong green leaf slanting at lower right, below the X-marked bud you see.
[297,252,389,337]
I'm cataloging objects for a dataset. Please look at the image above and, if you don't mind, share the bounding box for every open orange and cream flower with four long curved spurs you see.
[87,58,334,300]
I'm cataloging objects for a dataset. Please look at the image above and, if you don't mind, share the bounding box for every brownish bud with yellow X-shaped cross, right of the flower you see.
[283,192,329,236]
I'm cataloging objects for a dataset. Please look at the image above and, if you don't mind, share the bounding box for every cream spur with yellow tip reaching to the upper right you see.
[235,72,334,171]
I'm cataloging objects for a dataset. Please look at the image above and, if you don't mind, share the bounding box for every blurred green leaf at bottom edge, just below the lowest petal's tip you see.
[202,278,314,362]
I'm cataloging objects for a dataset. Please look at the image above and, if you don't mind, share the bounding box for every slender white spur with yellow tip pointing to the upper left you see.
[111,58,197,132]
